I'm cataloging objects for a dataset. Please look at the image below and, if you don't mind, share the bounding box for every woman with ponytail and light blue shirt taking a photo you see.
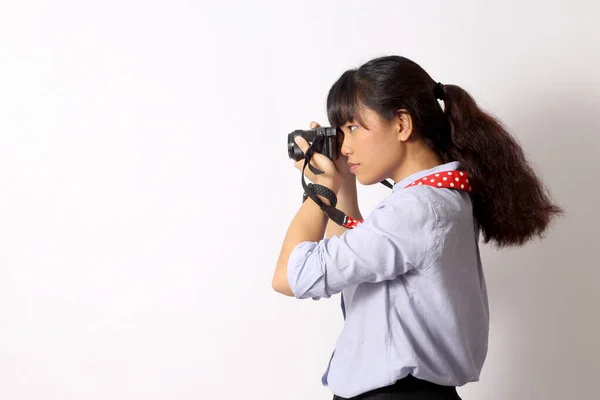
[273,56,561,399]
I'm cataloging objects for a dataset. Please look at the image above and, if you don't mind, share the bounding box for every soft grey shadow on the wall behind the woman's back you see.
[468,87,600,400]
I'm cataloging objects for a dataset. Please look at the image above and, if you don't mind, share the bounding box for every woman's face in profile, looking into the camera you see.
[341,109,404,185]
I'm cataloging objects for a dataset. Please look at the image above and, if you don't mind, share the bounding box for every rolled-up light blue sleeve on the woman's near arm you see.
[288,189,439,300]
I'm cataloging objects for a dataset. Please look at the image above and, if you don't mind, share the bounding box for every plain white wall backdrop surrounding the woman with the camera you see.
[0,0,600,400]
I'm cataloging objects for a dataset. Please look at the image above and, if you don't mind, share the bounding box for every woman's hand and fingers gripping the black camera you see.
[294,121,344,194]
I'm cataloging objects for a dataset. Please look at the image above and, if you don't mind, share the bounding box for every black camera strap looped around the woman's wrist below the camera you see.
[302,134,393,229]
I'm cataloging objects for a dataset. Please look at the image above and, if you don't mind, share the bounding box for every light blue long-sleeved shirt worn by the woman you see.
[288,162,489,397]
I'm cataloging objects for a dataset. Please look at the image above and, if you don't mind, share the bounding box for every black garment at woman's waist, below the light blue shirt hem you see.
[333,375,461,400]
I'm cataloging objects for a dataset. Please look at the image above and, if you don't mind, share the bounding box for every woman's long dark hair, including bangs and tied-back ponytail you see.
[327,56,562,247]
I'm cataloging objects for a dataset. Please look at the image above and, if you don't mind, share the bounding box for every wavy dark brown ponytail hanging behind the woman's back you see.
[443,85,562,247]
